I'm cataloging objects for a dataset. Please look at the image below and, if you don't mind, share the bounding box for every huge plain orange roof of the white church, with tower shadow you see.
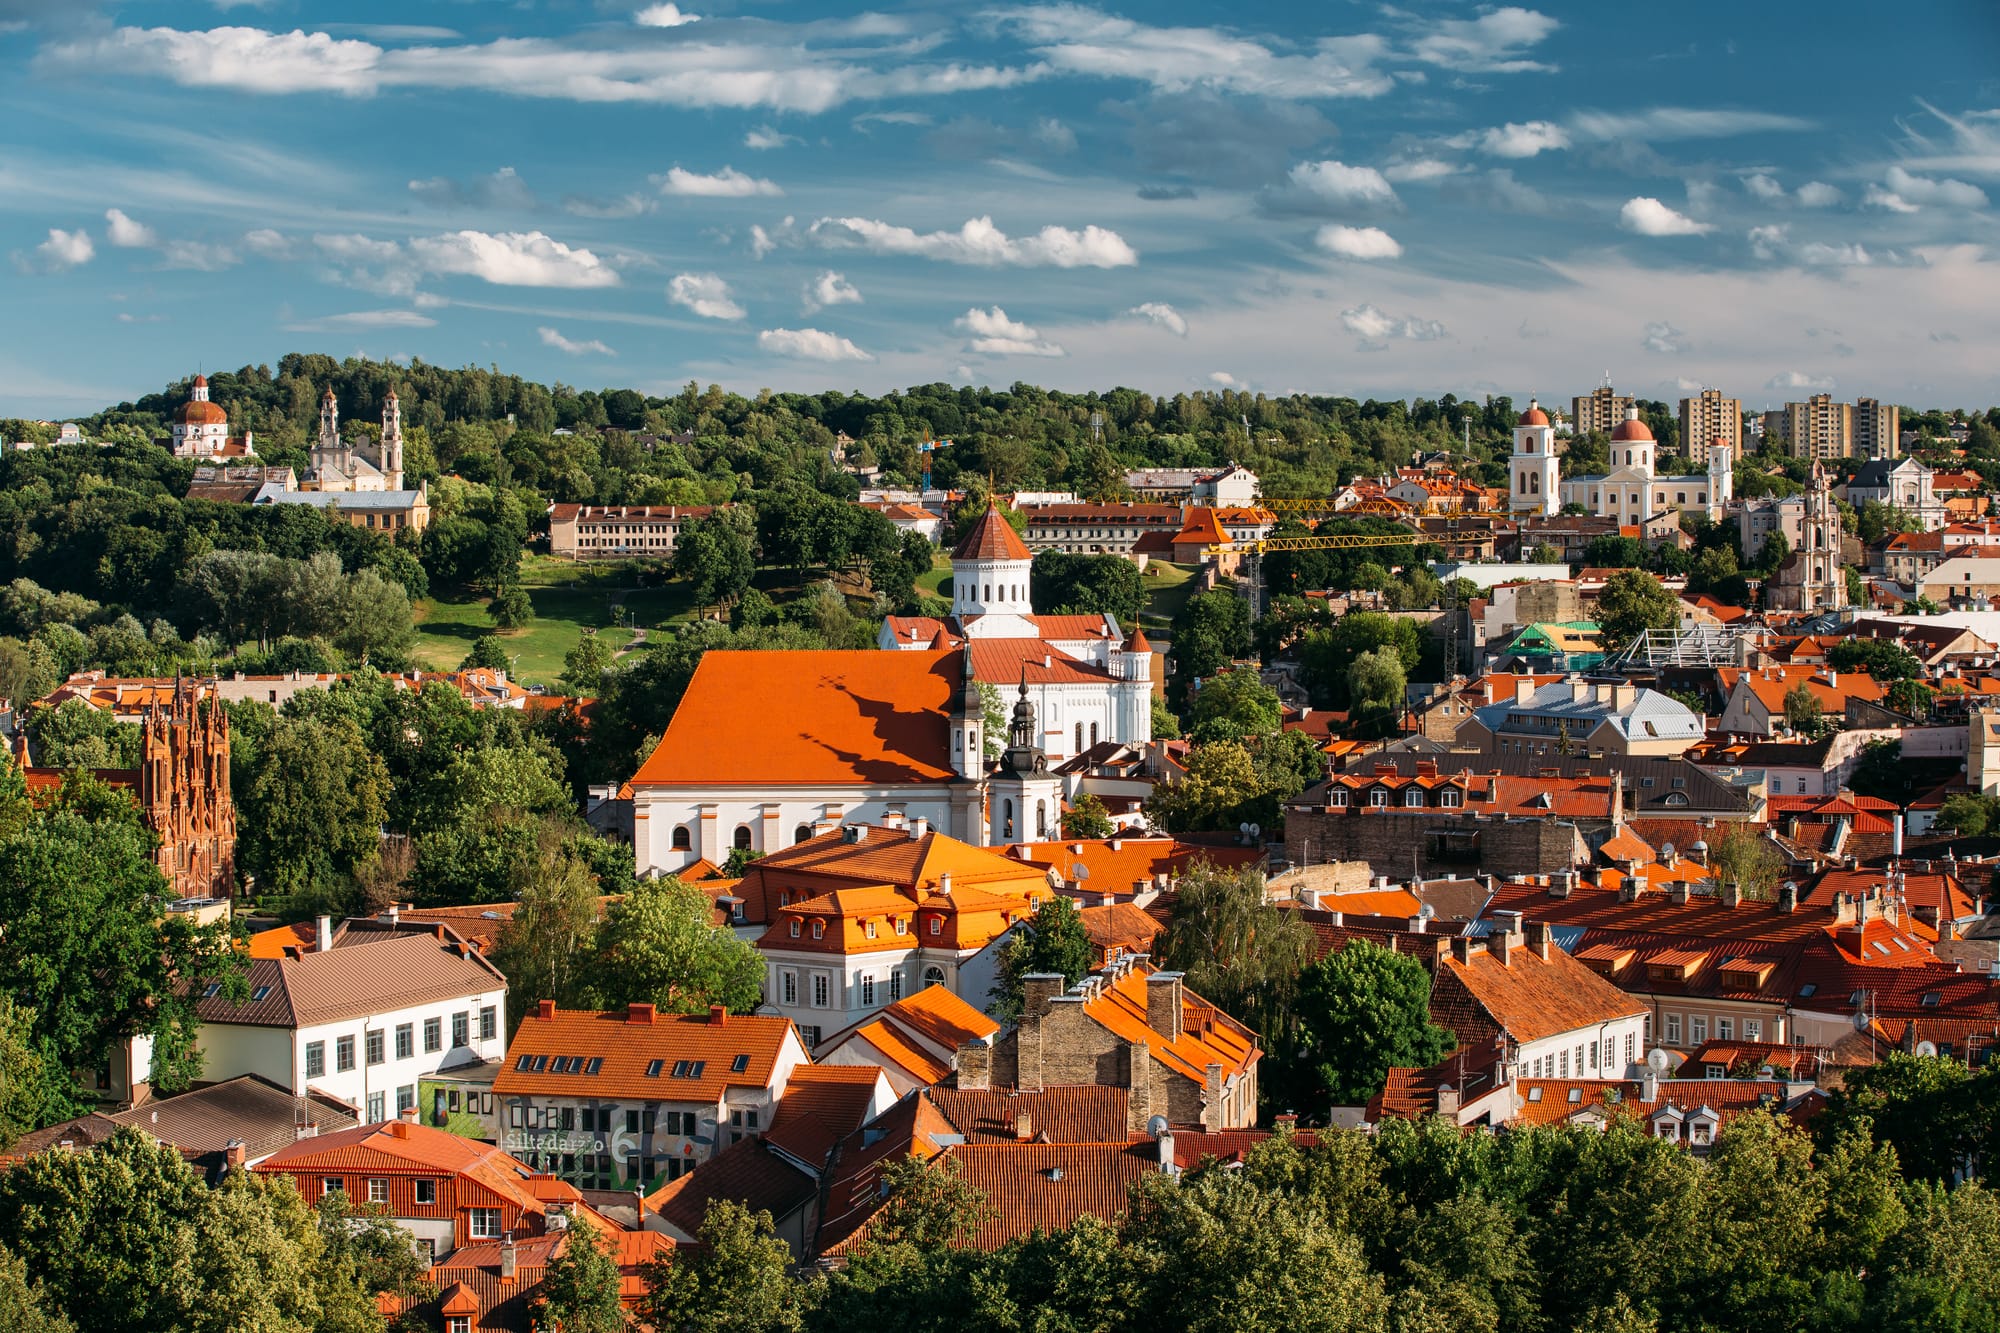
[632,648,962,787]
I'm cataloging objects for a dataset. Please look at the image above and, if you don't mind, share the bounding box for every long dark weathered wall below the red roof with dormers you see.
[1284,807,1584,881]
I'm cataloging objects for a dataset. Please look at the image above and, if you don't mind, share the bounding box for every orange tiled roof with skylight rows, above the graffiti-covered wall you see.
[494,1001,804,1103]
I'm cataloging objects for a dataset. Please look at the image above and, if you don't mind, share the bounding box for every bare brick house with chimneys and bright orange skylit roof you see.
[958,957,1262,1131]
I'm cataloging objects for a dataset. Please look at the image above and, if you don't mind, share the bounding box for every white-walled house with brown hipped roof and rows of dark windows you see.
[130,927,506,1125]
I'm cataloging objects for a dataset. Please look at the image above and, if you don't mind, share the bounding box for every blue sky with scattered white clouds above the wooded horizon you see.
[0,0,2000,414]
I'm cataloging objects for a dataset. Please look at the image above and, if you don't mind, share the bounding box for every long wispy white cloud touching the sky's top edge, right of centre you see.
[996,4,1396,98]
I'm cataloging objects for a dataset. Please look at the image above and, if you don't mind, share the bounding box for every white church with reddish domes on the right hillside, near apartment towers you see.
[1508,398,1736,524]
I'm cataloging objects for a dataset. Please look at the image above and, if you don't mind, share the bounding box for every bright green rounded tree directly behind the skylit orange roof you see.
[596,877,764,1013]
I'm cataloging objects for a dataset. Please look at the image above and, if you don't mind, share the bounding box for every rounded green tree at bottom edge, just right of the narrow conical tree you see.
[638,1199,816,1333]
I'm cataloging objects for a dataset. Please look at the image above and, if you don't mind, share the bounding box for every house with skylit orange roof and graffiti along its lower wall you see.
[492,999,808,1189]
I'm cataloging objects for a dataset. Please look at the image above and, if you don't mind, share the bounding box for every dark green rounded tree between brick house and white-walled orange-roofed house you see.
[1298,939,1456,1107]
